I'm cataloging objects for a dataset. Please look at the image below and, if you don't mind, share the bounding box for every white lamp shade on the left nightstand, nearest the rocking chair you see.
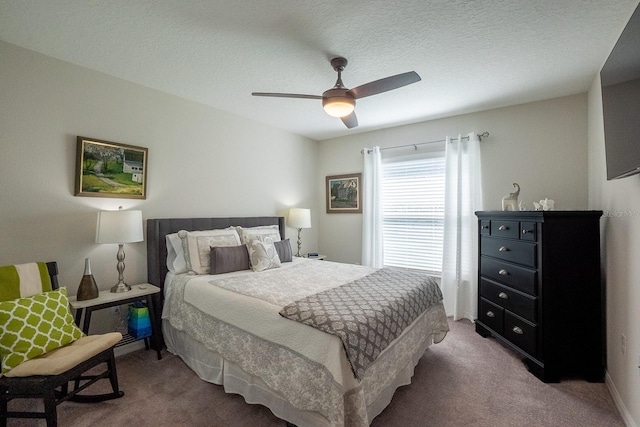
[96,211,144,244]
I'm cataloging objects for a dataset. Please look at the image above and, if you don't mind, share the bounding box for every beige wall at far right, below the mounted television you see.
[589,74,640,426]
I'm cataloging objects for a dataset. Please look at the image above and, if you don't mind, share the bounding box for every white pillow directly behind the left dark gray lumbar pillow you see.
[178,227,241,274]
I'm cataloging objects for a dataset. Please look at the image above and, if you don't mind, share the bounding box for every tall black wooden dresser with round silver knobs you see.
[476,211,605,382]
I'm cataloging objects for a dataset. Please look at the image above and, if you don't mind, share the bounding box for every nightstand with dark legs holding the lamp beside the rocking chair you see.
[69,283,162,360]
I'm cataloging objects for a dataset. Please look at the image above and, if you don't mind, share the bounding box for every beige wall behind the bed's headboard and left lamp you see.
[0,42,318,295]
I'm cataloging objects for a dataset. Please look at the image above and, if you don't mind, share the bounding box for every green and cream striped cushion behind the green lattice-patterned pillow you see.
[0,262,51,301]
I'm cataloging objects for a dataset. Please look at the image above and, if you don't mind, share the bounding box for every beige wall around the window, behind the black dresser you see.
[316,94,587,263]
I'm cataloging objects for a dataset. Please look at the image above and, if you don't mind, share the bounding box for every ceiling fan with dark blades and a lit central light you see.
[251,57,420,129]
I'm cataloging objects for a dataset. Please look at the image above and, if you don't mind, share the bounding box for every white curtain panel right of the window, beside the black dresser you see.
[441,132,482,322]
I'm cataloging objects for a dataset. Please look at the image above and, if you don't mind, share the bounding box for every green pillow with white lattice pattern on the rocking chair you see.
[0,288,84,374]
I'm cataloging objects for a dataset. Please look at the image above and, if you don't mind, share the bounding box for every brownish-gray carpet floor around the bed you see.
[8,320,624,427]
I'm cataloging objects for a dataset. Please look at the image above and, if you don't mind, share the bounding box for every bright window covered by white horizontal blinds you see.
[382,152,445,274]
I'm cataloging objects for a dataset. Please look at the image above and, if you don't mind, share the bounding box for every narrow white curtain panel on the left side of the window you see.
[362,146,384,268]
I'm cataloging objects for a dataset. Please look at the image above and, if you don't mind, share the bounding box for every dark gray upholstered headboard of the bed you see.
[147,216,284,289]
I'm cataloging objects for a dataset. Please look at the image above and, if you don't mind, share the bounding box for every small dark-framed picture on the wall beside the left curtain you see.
[326,173,362,213]
